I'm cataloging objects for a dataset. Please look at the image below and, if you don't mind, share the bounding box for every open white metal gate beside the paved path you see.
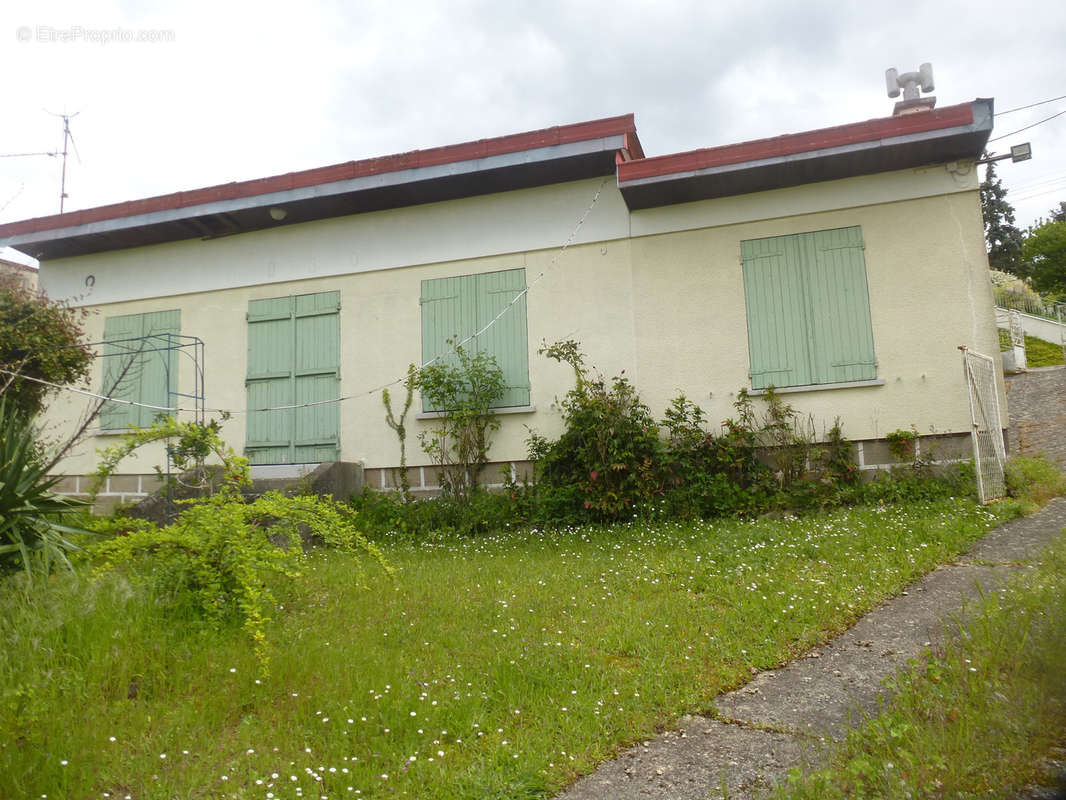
[959,347,1006,502]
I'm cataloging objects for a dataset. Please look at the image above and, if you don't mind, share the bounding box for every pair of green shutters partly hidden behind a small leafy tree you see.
[421,269,530,411]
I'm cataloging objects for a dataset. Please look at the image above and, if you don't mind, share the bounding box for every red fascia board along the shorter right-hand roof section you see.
[618,102,973,183]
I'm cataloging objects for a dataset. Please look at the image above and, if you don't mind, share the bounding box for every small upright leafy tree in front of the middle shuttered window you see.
[414,347,507,502]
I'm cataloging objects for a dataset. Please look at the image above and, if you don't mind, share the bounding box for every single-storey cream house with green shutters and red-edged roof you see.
[0,99,1006,507]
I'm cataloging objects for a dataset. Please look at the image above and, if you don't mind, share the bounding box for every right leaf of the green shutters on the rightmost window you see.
[806,227,877,383]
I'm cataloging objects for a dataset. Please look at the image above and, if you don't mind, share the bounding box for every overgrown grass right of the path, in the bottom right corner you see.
[773,535,1066,800]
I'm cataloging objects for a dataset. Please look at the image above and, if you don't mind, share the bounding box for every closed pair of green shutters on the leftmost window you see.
[100,309,181,430]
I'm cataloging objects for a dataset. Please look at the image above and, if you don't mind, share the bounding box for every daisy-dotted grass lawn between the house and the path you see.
[0,500,1017,800]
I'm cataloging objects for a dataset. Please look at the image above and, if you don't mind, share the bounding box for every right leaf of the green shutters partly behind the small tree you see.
[475,269,530,407]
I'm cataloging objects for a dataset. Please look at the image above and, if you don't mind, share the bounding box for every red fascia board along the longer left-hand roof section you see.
[0,114,631,237]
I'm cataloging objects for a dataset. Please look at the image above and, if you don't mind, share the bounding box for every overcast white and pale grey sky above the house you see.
[0,0,1066,263]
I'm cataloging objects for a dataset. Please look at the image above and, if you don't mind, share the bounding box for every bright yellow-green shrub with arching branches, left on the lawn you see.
[90,417,390,671]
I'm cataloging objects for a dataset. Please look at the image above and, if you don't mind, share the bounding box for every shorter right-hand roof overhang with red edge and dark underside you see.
[618,98,992,209]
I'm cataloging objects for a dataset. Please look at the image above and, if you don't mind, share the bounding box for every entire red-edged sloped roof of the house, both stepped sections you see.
[0,98,992,259]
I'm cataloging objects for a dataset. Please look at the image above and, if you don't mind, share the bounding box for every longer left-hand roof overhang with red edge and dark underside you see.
[0,114,644,260]
